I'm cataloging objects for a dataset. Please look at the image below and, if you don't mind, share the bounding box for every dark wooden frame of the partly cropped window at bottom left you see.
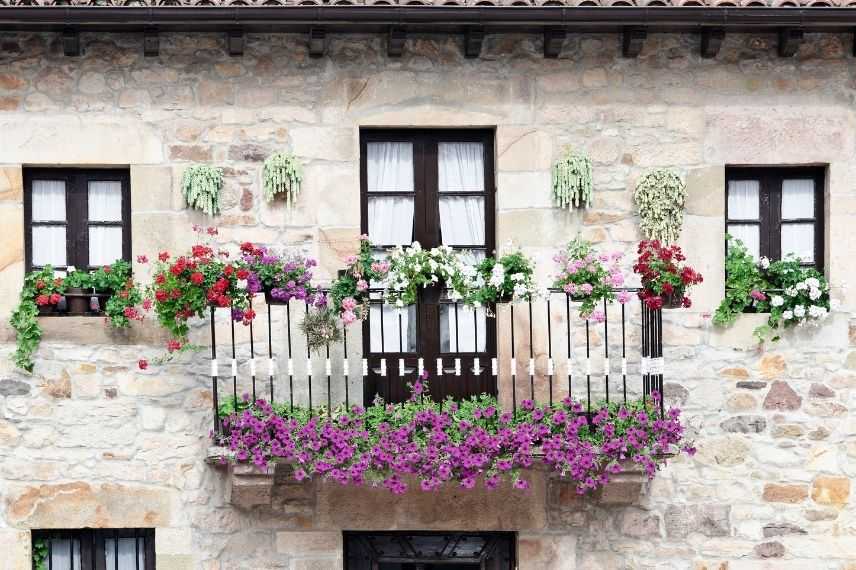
[32,528,155,570]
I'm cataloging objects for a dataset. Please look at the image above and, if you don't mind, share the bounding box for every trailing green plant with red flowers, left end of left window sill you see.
[9,265,65,372]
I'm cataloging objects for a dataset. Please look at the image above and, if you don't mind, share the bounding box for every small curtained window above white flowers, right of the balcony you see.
[725,167,824,271]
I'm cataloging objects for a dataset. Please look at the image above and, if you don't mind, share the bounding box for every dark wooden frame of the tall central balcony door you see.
[360,128,496,402]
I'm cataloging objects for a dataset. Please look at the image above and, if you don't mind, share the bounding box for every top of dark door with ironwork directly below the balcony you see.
[345,532,515,570]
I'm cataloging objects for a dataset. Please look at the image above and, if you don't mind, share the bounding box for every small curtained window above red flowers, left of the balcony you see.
[24,169,131,271]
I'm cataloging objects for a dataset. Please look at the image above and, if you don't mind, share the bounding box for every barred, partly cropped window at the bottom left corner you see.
[32,529,155,570]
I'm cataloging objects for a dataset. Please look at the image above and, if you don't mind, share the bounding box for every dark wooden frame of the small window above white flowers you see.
[725,166,826,273]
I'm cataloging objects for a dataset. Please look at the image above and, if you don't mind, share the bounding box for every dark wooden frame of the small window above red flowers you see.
[24,168,131,271]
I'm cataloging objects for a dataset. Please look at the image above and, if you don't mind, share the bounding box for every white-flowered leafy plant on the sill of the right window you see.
[713,236,831,342]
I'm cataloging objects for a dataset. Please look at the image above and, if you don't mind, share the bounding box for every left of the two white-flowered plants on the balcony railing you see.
[385,241,467,307]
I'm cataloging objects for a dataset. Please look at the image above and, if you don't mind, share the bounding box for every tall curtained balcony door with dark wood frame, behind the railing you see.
[360,130,495,401]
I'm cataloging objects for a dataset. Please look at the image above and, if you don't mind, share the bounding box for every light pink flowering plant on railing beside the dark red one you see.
[553,233,630,322]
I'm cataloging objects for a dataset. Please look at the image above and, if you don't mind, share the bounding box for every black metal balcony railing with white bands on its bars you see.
[210,289,663,431]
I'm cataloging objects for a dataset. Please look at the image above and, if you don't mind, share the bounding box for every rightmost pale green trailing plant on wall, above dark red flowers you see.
[633,168,687,244]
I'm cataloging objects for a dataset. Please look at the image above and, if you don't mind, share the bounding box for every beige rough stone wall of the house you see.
[0,32,856,570]
